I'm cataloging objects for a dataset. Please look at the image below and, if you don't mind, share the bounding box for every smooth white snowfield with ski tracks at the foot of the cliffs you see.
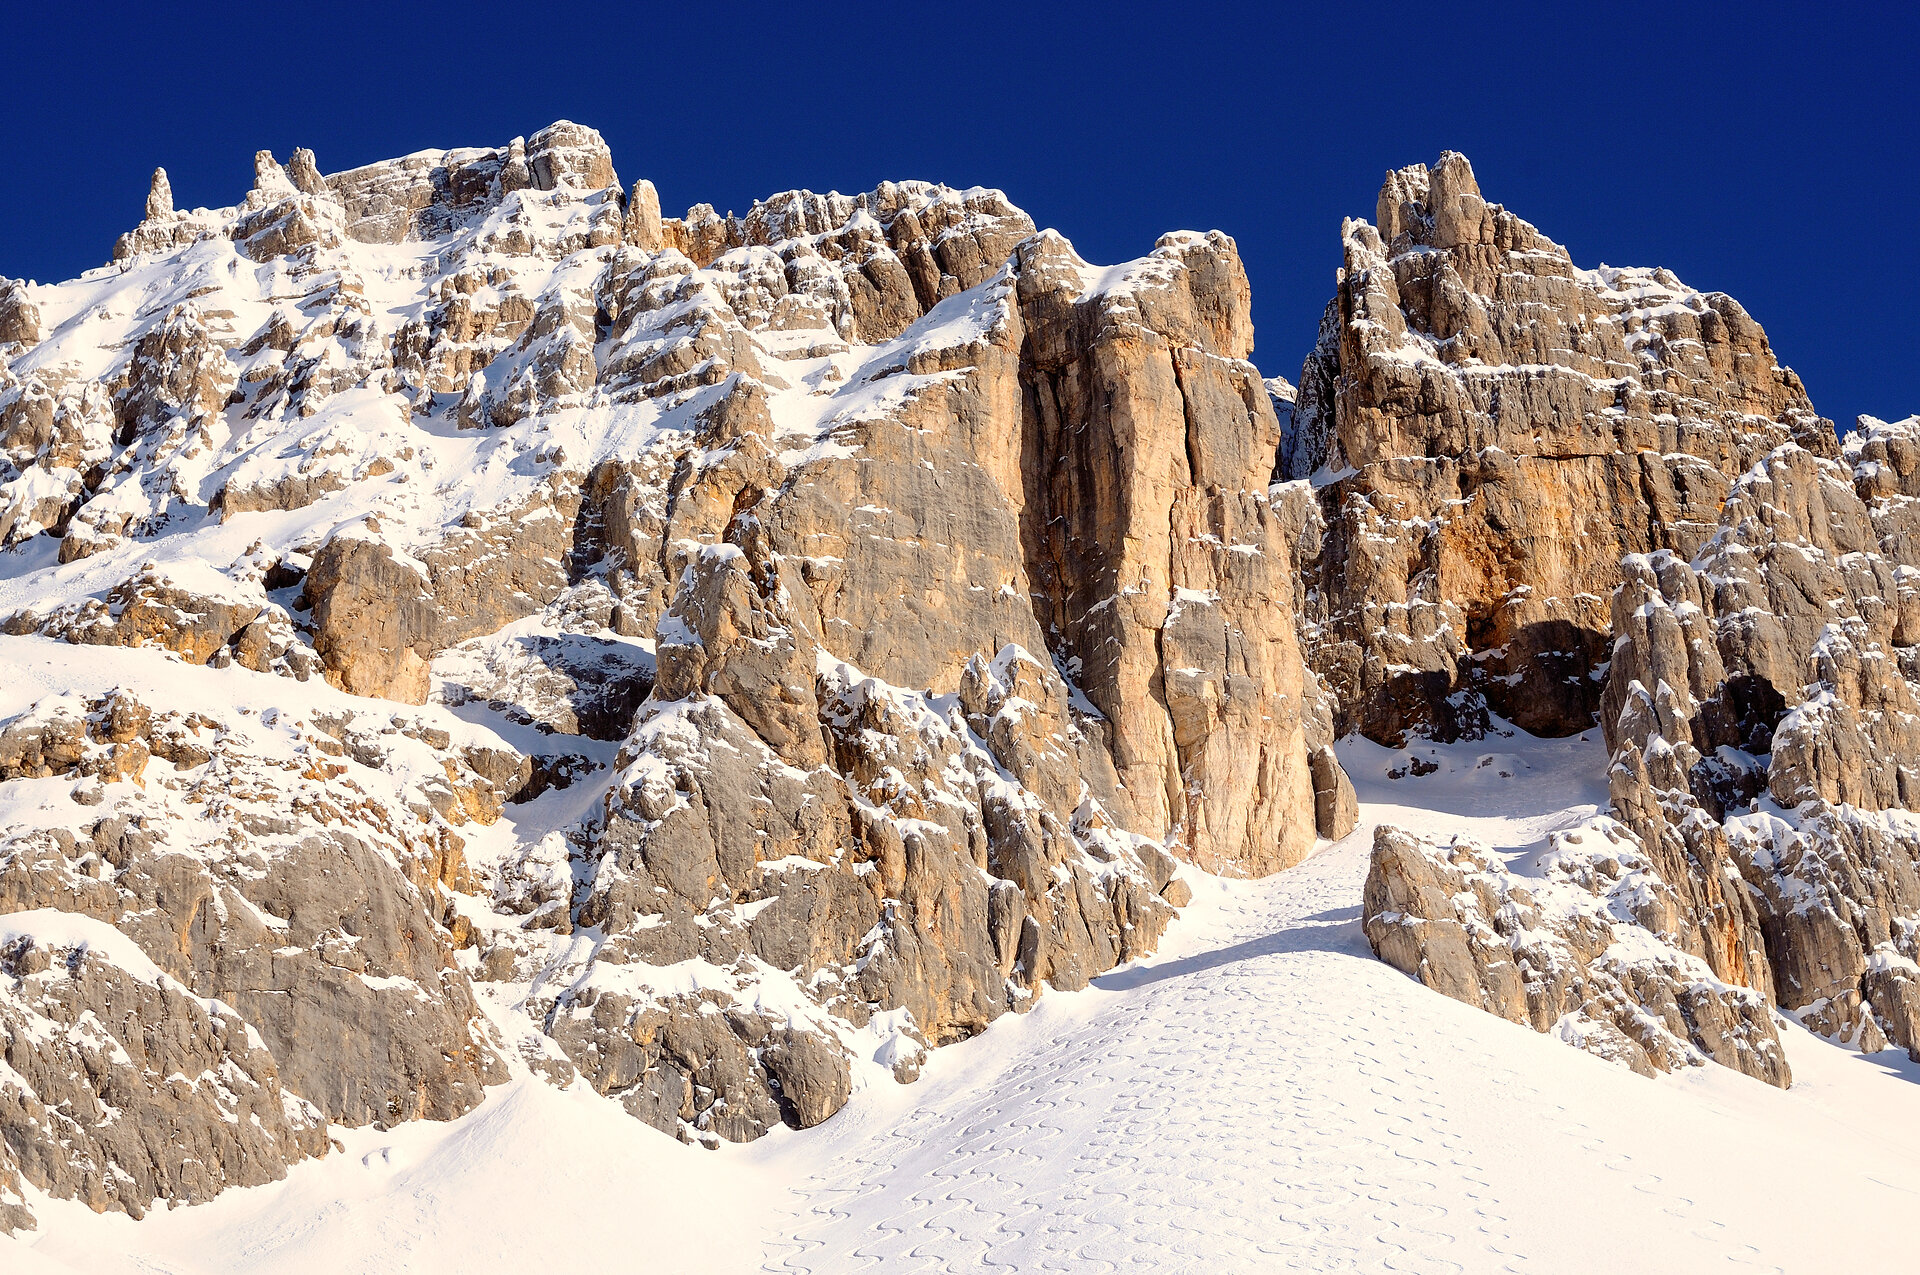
[15,732,1920,1275]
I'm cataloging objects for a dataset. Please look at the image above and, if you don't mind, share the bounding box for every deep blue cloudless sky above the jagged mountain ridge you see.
[0,0,1920,426]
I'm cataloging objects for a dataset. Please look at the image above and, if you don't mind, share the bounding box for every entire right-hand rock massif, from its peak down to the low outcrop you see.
[1328,156,1920,1083]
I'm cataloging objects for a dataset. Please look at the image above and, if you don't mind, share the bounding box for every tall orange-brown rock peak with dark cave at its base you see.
[1284,152,1836,743]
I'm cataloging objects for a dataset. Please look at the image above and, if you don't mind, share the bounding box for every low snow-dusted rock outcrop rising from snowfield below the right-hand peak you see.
[1363,820,1791,1089]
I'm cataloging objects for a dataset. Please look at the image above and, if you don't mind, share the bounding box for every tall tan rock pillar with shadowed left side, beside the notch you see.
[1020,234,1319,872]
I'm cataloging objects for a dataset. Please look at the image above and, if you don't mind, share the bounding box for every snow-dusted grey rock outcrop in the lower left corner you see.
[0,689,505,1215]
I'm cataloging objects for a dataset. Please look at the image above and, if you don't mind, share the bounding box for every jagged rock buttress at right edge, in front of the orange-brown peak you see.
[1603,421,1920,1056]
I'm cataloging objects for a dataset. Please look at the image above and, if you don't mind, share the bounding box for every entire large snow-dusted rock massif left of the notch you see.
[0,123,1354,1212]
